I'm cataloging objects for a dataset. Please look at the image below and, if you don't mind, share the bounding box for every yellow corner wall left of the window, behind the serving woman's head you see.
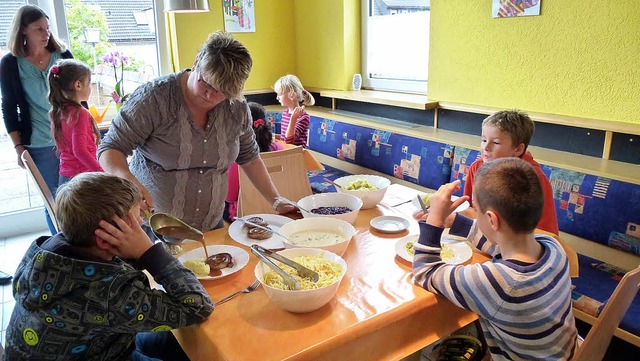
[168,0,360,90]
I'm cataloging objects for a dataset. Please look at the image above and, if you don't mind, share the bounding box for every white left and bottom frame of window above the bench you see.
[360,0,429,95]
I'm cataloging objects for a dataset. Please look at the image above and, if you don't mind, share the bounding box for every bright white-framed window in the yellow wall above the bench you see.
[362,0,430,94]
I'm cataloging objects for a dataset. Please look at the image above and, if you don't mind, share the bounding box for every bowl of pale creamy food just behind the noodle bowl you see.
[280,218,356,256]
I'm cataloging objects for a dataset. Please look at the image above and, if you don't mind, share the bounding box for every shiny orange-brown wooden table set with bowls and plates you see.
[174,185,487,360]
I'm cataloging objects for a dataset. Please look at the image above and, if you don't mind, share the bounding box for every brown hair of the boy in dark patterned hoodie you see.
[55,172,140,247]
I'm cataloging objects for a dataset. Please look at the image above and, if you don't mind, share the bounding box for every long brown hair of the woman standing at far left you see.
[7,5,66,58]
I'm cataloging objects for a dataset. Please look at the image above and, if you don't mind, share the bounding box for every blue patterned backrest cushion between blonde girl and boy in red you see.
[309,116,453,189]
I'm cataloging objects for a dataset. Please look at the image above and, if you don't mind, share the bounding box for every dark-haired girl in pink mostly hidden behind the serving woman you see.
[222,102,283,223]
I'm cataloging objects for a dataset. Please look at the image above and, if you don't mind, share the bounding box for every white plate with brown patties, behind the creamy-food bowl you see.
[229,214,292,249]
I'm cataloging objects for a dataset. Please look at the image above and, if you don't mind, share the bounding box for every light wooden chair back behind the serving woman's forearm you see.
[237,146,312,217]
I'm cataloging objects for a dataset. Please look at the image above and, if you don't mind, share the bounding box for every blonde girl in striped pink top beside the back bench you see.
[273,74,316,148]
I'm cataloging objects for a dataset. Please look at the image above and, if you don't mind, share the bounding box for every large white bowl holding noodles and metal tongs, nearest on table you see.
[254,248,347,313]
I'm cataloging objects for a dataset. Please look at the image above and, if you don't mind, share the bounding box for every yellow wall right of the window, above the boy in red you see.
[428,0,640,124]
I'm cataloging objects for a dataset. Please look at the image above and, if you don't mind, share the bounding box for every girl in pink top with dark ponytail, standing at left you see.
[49,59,102,185]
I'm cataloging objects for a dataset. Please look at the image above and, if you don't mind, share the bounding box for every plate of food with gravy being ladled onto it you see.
[178,245,249,280]
